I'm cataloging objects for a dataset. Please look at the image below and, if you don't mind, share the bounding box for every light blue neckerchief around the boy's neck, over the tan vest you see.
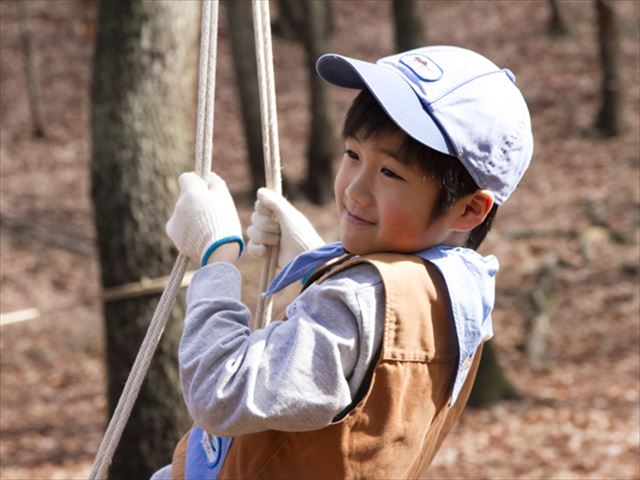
[263,242,498,405]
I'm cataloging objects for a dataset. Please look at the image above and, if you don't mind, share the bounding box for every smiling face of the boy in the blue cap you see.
[334,127,460,255]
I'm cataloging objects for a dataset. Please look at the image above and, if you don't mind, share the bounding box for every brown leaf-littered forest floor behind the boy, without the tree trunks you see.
[0,0,640,479]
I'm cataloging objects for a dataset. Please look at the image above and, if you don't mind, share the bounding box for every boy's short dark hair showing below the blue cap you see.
[342,89,498,250]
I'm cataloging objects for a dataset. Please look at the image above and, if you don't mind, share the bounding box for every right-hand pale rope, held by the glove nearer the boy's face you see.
[251,0,282,330]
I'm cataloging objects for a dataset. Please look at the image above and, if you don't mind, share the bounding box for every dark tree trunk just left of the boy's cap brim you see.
[300,0,336,204]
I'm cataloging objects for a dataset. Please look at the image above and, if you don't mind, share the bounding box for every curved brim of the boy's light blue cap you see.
[316,53,456,156]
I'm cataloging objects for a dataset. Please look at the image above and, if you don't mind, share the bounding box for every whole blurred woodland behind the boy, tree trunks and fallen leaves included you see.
[0,0,640,480]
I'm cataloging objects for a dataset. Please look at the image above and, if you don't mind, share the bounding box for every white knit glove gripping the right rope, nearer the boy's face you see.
[247,188,325,268]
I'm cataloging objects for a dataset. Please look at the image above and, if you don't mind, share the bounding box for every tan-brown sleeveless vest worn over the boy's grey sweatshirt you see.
[172,254,481,480]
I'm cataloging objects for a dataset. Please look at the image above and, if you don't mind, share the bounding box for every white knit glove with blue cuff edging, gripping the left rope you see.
[166,172,242,261]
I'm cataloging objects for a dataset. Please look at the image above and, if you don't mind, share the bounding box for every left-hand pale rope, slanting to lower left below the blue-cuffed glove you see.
[89,0,218,480]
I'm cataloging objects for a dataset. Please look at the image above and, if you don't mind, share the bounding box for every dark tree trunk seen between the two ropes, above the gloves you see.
[225,0,264,190]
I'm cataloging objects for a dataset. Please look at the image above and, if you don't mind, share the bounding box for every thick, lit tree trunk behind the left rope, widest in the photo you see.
[91,0,199,480]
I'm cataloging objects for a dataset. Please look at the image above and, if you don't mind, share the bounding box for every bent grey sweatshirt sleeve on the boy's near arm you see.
[179,263,384,436]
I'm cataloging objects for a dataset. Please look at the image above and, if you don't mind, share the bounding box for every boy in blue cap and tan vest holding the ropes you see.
[156,47,533,479]
